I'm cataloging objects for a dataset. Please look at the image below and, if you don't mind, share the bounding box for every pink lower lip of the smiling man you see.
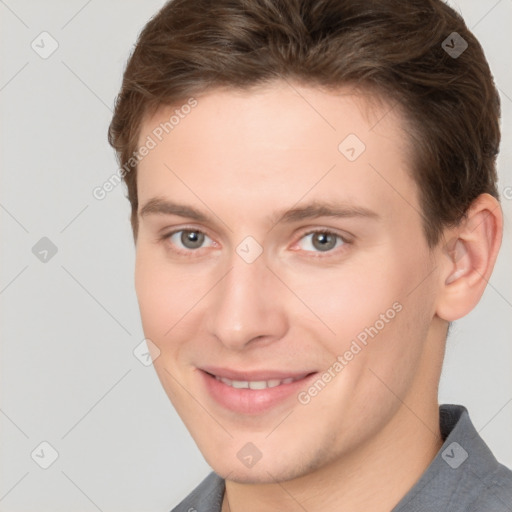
[199,370,316,414]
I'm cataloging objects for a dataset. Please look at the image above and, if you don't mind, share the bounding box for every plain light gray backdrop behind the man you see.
[0,0,512,512]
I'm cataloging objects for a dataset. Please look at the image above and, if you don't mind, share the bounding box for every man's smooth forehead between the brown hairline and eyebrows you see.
[137,82,415,225]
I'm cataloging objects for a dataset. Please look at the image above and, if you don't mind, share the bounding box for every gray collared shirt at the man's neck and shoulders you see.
[171,405,512,512]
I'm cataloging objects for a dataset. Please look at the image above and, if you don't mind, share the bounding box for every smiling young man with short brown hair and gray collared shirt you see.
[109,0,512,512]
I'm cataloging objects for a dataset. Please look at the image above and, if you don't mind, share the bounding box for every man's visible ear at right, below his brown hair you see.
[436,193,503,322]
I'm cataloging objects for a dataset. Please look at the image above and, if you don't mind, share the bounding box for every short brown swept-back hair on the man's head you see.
[109,0,500,247]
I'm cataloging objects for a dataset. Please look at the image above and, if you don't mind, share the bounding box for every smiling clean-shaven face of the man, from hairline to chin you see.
[136,82,445,482]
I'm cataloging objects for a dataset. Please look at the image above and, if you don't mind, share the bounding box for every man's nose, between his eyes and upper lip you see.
[207,248,288,351]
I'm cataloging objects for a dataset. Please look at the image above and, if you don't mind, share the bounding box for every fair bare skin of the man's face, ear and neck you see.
[135,82,502,512]
